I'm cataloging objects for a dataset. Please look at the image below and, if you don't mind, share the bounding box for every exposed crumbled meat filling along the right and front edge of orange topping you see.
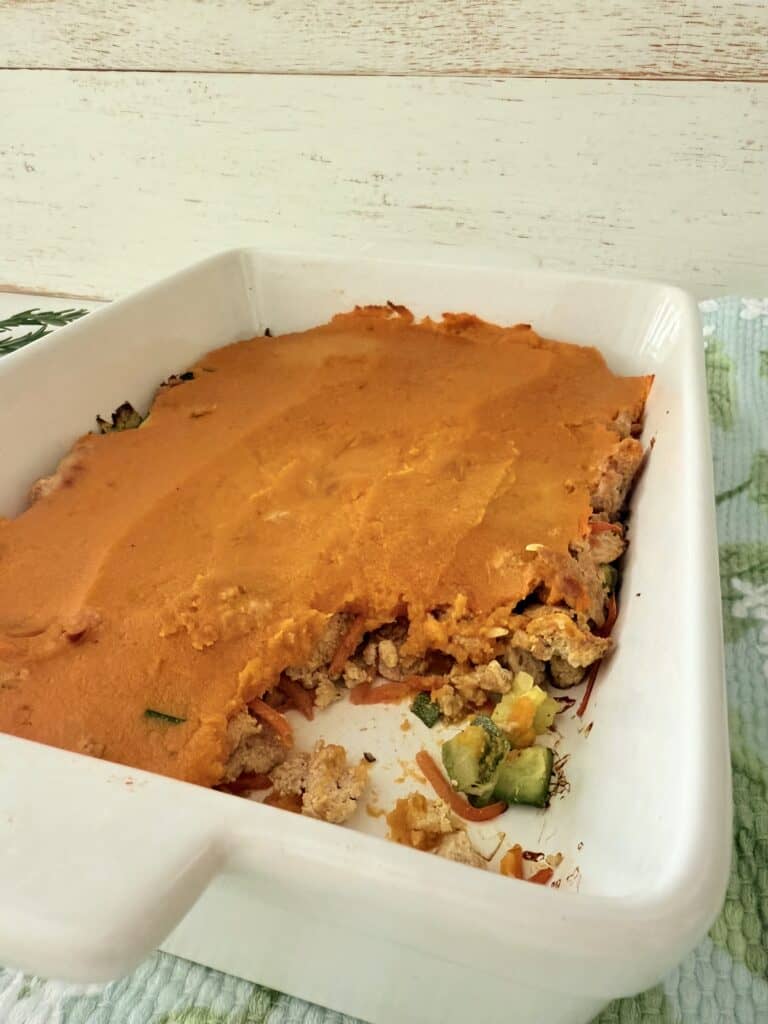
[286,501,630,721]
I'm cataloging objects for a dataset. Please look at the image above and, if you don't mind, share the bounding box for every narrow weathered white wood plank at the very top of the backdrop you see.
[0,0,768,80]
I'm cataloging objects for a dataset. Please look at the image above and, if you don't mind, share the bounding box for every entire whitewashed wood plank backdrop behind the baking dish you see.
[0,0,768,299]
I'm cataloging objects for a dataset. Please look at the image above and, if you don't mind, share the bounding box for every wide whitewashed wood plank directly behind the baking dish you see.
[0,71,768,298]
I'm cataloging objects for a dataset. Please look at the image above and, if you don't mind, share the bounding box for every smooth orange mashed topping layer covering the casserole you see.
[0,307,649,785]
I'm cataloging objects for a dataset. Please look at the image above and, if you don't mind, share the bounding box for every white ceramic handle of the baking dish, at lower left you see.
[0,735,224,983]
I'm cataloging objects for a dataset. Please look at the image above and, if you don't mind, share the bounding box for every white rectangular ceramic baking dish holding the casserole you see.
[0,250,730,1024]
